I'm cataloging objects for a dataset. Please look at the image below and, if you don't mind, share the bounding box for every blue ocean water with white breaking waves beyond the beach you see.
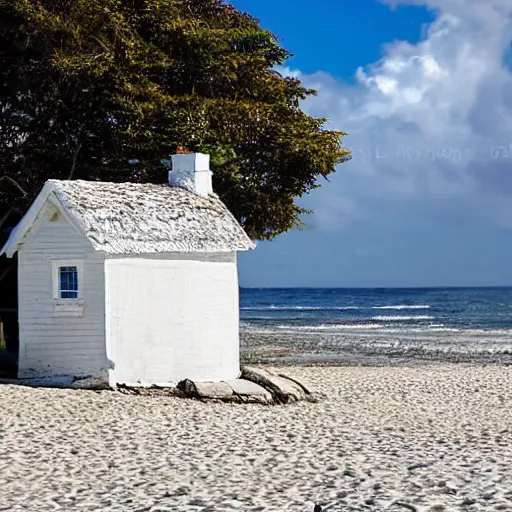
[240,288,512,364]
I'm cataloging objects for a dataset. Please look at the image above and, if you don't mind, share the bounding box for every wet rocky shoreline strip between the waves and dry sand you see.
[240,329,512,366]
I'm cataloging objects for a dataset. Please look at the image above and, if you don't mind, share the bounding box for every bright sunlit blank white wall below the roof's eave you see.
[105,254,240,385]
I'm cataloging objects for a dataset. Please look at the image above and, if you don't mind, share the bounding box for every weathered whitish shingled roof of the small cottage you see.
[0,180,254,256]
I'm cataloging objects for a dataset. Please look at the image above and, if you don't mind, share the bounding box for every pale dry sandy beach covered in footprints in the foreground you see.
[0,363,512,512]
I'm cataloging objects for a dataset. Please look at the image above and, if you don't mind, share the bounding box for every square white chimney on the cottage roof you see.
[169,153,213,196]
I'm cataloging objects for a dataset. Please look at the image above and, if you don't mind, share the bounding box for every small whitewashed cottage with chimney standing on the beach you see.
[1,154,254,386]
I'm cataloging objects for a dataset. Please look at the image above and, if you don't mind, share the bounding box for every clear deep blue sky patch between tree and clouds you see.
[231,0,433,81]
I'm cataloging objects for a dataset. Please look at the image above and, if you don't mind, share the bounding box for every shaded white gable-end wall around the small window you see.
[18,205,108,377]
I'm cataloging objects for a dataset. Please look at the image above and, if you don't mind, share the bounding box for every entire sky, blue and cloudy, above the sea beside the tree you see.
[231,0,512,287]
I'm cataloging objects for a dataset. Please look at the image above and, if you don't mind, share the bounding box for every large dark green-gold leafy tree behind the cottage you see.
[0,0,349,239]
